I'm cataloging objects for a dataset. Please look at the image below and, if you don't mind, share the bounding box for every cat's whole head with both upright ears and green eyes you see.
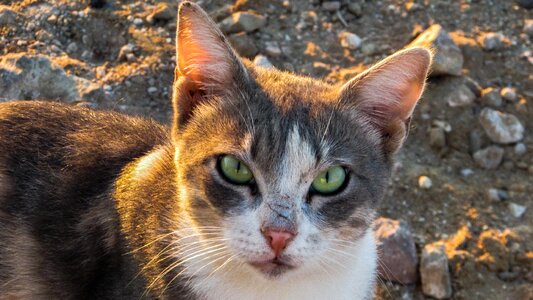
[173,3,431,278]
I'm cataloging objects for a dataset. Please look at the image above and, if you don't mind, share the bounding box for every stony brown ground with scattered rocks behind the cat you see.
[0,0,533,299]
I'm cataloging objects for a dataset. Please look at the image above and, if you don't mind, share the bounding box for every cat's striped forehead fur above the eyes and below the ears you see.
[181,67,379,170]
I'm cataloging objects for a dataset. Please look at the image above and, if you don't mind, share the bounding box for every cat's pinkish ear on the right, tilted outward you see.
[340,48,431,154]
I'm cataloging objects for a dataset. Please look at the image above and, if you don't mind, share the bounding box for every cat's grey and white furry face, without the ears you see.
[178,70,389,275]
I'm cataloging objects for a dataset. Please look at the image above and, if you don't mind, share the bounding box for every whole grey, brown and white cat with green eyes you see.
[0,2,431,299]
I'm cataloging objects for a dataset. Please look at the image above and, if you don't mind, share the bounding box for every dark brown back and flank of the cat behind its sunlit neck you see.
[0,102,169,299]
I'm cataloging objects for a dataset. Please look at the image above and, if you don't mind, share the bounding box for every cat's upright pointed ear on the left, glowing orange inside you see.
[173,2,248,130]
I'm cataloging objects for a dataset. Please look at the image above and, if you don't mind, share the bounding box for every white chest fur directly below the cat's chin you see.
[191,229,376,300]
